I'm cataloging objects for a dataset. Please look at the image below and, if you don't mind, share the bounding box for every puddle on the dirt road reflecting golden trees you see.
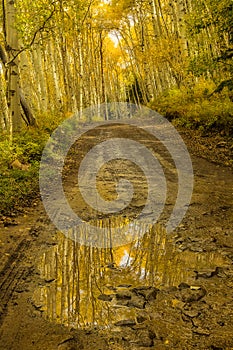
[33,221,226,328]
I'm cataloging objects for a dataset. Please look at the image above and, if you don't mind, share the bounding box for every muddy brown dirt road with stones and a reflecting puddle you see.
[0,122,233,350]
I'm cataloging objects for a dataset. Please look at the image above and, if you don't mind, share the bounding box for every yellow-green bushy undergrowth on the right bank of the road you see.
[149,80,233,136]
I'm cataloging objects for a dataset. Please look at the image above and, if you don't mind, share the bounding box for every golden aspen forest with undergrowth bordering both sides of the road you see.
[0,0,233,213]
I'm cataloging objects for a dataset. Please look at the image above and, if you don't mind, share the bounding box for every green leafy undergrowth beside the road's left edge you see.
[0,130,49,216]
